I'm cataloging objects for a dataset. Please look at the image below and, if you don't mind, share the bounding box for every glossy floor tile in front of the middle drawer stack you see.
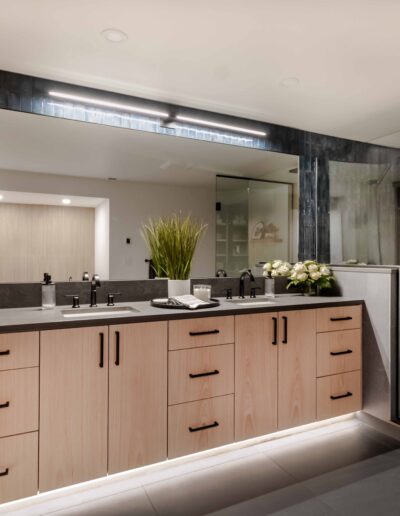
[145,454,294,516]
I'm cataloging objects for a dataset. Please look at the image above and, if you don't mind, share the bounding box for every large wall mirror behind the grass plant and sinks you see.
[0,106,298,282]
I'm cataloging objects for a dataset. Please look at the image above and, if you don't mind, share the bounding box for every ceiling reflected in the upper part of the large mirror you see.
[0,109,298,187]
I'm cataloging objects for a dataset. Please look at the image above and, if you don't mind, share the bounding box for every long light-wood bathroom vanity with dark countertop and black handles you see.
[0,297,362,502]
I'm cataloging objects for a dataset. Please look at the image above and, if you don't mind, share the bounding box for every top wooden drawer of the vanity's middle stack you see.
[168,316,235,350]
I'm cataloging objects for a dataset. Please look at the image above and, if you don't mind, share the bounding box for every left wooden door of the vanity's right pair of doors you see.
[235,313,278,441]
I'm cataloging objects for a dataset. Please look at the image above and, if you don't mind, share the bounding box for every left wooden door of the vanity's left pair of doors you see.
[39,326,108,491]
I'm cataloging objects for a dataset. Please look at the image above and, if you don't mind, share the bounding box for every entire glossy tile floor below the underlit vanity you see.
[0,419,400,516]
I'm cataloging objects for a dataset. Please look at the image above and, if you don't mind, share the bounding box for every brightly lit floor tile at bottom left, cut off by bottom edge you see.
[47,488,157,516]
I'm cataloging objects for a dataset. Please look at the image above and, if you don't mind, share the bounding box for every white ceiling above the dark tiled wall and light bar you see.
[0,0,400,147]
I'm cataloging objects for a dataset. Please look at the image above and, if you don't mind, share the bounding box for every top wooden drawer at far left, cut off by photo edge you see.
[0,331,39,371]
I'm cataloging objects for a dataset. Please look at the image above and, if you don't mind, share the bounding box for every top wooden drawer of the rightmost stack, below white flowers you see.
[317,305,362,332]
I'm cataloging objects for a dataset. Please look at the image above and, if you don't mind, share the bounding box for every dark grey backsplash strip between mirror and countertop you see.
[0,277,287,308]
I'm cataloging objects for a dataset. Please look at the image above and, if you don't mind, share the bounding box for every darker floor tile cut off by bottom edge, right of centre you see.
[210,484,337,516]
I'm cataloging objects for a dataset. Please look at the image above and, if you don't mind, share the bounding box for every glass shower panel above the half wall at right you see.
[329,161,400,265]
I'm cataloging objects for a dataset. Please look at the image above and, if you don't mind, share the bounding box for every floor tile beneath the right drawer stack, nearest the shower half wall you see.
[265,427,393,481]
